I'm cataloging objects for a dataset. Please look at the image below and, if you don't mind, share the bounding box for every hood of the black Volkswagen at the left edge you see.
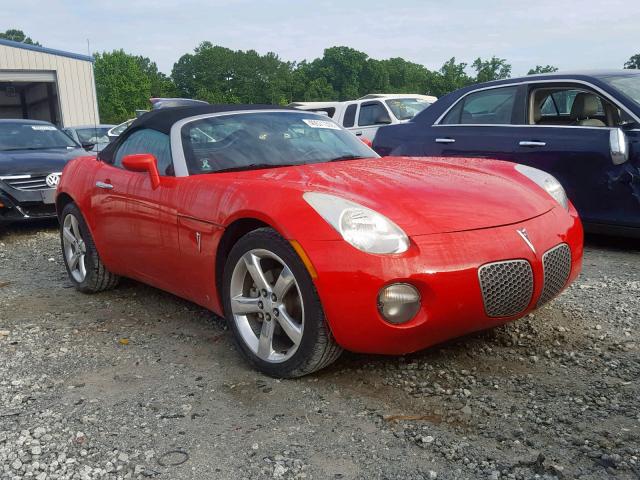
[0,148,87,175]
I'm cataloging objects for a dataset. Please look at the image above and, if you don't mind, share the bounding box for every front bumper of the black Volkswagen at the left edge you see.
[0,180,56,222]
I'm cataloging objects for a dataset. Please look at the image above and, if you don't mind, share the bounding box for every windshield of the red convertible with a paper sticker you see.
[181,111,377,174]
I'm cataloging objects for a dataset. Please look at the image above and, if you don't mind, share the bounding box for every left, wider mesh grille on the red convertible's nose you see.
[478,260,533,317]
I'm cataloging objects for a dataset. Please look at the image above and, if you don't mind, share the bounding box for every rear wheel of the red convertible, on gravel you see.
[60,202,120,293]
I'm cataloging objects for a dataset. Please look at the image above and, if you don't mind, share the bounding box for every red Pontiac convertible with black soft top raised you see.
[56,105,583,377]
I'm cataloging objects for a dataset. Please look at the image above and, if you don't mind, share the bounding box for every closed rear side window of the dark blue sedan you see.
[441,87,518,125]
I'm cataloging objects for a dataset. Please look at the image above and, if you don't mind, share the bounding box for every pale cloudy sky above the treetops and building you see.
[5,0,640,76]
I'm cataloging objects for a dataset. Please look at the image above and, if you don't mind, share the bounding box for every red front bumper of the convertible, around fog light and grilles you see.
[303,207,583,354]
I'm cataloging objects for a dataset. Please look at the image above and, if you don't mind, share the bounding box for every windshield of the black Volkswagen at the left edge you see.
[0,122,78,151]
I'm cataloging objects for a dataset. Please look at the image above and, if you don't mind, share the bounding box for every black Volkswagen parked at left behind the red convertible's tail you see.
[0,120,87,224]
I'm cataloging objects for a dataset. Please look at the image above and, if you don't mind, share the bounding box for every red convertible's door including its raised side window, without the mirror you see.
[91,129,183,293]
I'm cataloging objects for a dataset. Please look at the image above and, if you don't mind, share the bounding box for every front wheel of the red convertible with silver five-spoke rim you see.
[222,228,342,378]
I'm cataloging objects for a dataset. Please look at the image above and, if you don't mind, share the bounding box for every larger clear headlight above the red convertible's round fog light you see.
[303,192,409,254]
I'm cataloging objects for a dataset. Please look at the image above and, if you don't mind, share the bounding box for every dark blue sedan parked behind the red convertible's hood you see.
[373,70,640,236]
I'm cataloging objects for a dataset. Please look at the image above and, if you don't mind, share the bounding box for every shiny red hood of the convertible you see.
[252,157,557,235]
